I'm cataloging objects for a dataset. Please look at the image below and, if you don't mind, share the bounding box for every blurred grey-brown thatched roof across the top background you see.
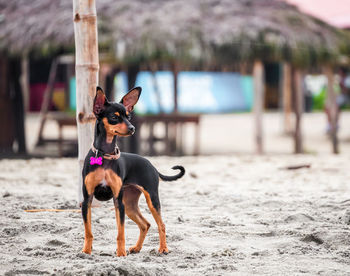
[0,0,350,65]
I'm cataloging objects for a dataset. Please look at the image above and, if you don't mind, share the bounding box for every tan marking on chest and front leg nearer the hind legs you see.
[105,170,126,257]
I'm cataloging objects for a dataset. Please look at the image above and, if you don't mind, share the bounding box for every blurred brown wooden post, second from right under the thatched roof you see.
[294,69,304,153]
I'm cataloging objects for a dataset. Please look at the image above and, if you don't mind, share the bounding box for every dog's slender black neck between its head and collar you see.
[93,120,117,153]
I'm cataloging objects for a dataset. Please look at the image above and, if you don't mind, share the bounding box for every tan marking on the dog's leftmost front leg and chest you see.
[82,168,104,254]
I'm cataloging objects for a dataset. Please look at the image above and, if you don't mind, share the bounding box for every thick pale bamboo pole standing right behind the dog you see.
[73,0,99,202]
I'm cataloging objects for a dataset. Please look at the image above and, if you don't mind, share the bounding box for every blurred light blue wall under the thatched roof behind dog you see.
[115,71,253,114]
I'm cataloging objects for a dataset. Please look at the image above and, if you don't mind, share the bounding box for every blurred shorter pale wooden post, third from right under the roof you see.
[282,62,292,134]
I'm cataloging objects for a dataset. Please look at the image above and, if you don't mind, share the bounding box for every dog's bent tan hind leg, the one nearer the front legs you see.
[123,185,151,253]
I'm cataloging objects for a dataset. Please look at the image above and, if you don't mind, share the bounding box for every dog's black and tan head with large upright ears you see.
[93,87,142,137]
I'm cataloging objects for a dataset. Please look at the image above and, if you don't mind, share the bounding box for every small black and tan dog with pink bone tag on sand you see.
[82,87,185,256]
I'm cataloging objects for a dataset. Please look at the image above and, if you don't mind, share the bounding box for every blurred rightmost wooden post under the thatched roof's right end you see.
[324,67,339,154]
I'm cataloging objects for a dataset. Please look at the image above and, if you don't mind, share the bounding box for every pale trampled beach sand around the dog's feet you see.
[0,155,350,275]
